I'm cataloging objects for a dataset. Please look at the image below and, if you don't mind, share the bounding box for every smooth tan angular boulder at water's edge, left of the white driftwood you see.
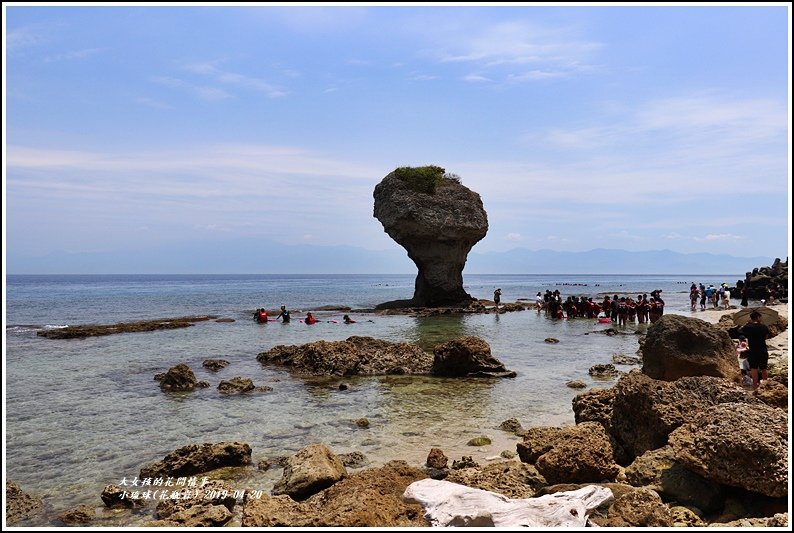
[273,444,347,500]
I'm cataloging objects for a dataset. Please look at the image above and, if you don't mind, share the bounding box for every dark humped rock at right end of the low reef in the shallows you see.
[431,336,516,377]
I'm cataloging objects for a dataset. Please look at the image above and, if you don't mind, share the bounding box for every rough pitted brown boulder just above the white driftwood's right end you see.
[516,422,620,484]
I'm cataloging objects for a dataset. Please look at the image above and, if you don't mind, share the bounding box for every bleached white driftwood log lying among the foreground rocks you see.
[403,479,613,527]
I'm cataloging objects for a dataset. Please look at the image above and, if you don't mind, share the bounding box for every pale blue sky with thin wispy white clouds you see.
[3,2,791,270]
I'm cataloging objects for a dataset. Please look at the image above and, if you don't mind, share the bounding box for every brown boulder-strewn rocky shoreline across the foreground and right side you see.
[6,304,789,527]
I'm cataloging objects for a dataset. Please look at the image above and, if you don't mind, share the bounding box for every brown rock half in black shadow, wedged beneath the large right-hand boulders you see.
[626,446,725,513]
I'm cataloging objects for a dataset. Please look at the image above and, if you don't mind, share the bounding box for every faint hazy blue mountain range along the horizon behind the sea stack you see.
[6,239,772,274]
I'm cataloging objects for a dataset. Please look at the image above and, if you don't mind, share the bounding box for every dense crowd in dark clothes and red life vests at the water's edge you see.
[535,289,664,325]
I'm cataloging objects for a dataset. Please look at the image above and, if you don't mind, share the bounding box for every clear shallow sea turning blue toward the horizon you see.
[3,274,744,526]
